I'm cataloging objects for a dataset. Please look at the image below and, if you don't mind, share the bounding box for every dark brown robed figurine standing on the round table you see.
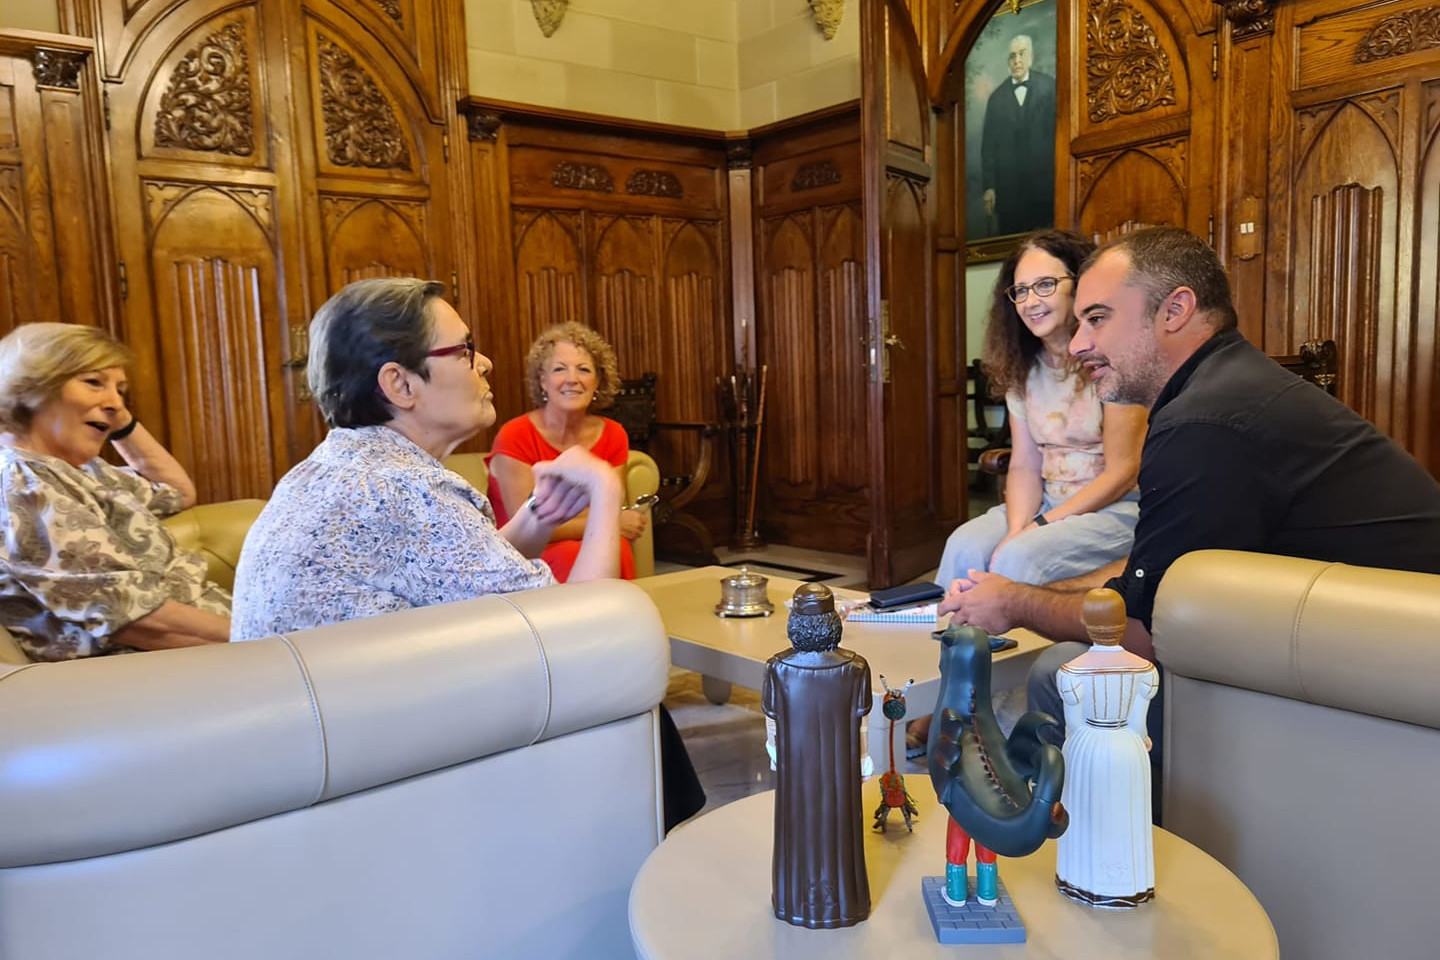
[762,584,871,928]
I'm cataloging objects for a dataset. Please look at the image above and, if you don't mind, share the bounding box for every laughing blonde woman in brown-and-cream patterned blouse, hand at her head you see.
[0,324,230,661]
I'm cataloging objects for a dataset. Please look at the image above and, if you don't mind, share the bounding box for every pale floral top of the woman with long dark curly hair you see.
[1005,361,1104,504]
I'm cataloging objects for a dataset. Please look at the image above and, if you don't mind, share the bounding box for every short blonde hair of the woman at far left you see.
[0,324,135,430]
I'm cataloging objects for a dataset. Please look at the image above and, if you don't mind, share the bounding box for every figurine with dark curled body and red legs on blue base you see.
[927,626,1068,943]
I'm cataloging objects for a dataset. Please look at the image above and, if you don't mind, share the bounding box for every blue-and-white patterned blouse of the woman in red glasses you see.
[230,426,554,640]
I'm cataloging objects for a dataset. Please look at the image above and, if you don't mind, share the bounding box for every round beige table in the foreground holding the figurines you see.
[629,777,1280,960]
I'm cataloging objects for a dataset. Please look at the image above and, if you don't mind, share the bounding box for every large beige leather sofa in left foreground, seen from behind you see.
[0,581,670,960]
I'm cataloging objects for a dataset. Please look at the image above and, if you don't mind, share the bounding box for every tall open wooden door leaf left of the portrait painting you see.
[861,0,956,587]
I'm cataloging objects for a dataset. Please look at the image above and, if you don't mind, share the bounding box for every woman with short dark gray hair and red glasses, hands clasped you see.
[232,278,622,640]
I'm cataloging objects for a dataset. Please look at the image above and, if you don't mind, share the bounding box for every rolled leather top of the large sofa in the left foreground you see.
[0,580,670,868]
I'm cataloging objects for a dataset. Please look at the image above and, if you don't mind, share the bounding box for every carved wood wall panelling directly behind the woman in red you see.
[462,99,734,535]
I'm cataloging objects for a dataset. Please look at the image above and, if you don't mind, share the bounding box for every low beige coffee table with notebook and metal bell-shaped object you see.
[635,567,1050,771]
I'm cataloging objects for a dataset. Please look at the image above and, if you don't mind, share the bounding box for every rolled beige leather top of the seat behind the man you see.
[1153,550,1440,727]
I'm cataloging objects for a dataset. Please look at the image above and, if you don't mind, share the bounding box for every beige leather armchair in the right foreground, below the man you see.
[1153,551,1440,960]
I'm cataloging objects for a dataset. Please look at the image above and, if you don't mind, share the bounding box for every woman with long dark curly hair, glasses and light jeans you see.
[939,230,1146,584]
